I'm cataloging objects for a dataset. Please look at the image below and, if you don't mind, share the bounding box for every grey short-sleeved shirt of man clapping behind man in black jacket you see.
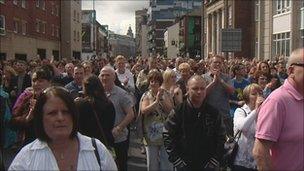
[203,72,231,116]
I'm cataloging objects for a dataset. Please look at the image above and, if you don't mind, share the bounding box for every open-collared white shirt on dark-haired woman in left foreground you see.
[8,133,117,170]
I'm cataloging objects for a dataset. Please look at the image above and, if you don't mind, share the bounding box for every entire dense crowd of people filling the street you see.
[0,48,304,171]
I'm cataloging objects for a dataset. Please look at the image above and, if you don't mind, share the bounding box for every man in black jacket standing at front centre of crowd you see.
[163,75,225,171]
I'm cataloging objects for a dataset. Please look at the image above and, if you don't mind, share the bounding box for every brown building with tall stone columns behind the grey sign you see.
[202,0,255,58]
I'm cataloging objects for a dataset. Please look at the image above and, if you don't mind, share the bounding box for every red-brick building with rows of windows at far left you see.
[0,0,61,60]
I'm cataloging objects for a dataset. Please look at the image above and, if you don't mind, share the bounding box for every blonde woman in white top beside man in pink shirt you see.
[232,84,264,171]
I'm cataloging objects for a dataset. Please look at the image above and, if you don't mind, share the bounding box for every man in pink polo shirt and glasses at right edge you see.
[253,48,304,170]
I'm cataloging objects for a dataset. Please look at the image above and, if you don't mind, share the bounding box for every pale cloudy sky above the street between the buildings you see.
[82,0,149,35]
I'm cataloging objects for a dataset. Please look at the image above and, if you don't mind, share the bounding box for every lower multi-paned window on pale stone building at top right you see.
[273,32,290,56]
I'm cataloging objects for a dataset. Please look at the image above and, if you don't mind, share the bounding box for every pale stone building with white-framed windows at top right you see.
[255,0,304,60]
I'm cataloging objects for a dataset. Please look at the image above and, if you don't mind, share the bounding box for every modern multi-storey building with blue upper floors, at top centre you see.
[148,0,202,55]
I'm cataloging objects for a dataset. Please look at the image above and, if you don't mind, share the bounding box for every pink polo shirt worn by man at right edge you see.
[255,80,304,170]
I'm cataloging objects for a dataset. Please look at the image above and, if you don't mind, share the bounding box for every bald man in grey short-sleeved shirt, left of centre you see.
[99,66,134,170]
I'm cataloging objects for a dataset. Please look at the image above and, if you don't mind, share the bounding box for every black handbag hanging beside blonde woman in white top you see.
[223,130,241,168]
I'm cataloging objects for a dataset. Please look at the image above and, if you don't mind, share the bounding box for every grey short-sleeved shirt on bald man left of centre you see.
[107,86,134,143]
